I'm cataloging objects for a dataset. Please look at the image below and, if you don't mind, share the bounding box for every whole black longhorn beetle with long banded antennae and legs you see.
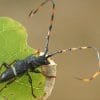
[0,0,100,97]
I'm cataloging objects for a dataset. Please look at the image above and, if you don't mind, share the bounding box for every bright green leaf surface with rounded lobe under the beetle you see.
[0,17,45,100]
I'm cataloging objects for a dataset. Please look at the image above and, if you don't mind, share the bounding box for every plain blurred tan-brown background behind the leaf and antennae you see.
[0,0,100,100]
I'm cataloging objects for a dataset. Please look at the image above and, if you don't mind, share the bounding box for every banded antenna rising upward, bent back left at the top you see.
[29,0,55,56]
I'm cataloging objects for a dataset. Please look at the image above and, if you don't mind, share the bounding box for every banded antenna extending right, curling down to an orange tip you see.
[47,46,100,82]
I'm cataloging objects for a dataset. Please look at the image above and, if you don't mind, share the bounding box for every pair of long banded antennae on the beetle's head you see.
[29,0,100,82]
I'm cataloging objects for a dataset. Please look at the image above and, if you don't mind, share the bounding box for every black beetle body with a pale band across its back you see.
[0,55,49,82]
